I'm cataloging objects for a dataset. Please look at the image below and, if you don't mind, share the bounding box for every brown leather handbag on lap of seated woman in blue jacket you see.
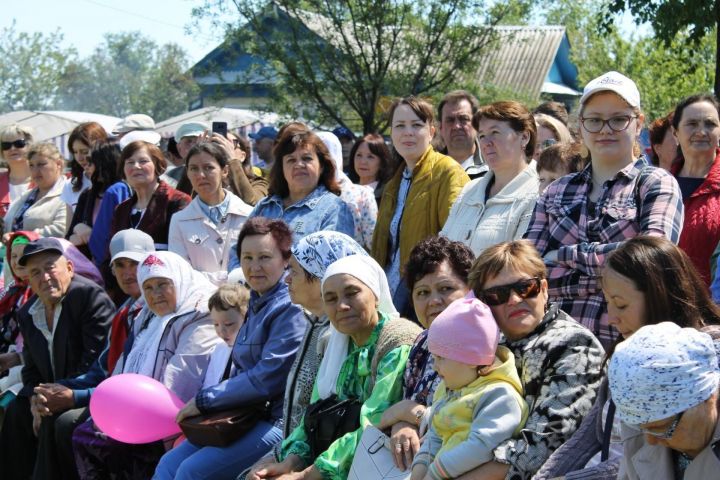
[180,403,268,447]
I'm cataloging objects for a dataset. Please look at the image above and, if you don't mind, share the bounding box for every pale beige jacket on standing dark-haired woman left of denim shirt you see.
[168,190,253,285]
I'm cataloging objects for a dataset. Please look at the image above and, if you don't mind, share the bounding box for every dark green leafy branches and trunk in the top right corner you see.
[603,0,720,96]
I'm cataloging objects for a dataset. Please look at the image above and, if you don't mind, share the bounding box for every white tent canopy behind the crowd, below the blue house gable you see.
[155,107,278,138]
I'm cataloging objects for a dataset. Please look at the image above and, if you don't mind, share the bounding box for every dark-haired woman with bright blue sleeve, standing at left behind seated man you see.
[65,143,130,268]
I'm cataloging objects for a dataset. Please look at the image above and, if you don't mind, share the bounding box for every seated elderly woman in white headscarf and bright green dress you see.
[248,255,420,480]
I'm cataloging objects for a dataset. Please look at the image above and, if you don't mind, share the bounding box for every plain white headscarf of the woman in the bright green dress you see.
[317,255,400,399]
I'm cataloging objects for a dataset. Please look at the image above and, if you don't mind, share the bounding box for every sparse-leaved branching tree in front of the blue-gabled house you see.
[191,0,516,132]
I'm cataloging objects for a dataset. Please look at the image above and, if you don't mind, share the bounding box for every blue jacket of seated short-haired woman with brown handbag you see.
[195,281,307,420]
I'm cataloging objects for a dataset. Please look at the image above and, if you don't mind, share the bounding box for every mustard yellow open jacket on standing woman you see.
[372,147,470,267]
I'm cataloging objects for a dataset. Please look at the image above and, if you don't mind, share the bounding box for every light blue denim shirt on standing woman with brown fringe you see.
[228,185,355,272]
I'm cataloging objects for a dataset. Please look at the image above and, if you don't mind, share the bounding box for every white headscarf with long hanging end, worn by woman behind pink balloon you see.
[123,251,217,377]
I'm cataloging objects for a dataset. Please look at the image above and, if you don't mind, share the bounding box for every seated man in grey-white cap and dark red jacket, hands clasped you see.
[26,229,155,480]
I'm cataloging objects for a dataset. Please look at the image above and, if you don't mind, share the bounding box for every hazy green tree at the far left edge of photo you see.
[0,22,77,112]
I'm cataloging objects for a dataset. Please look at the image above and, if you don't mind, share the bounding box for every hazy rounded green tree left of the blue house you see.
[61,32,198,120]
